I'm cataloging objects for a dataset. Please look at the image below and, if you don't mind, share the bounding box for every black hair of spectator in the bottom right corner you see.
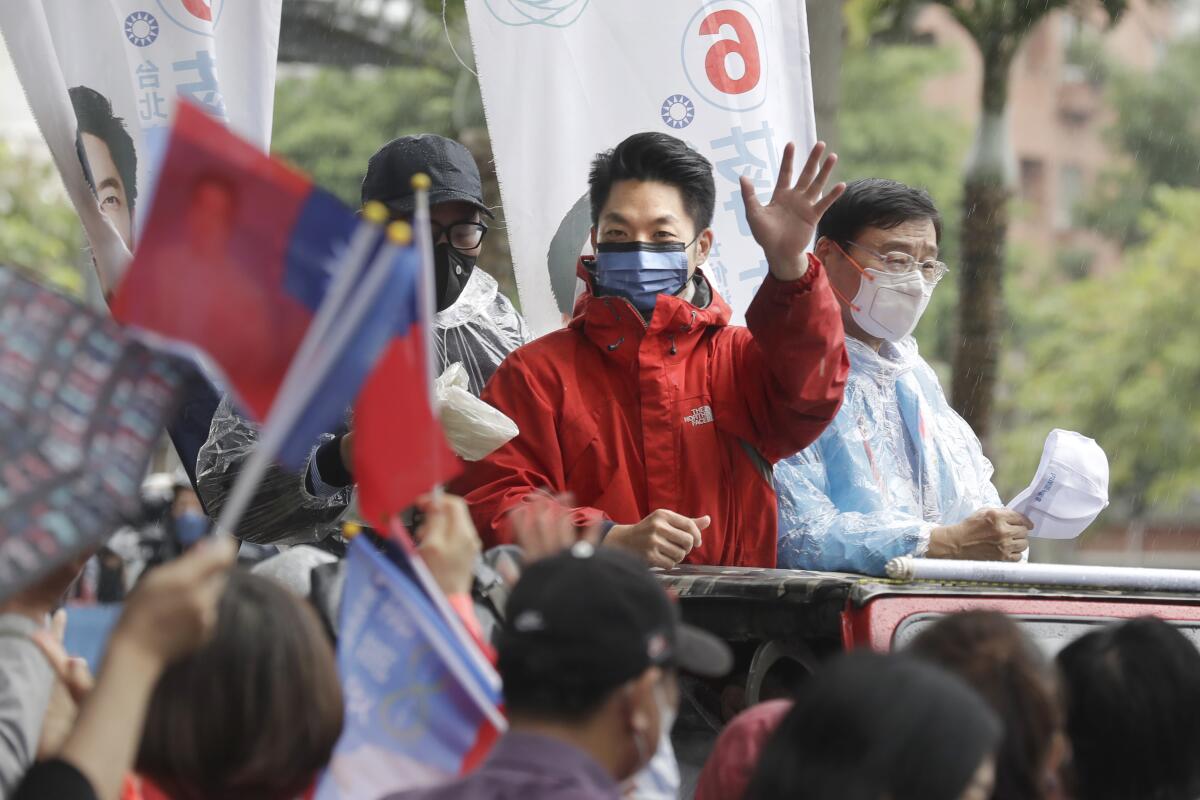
[1058,616,1200,800]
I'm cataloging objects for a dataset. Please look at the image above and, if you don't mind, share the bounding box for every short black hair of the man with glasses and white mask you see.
[817,178,942,246]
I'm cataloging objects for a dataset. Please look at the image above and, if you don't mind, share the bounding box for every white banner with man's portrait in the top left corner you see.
[0,0,282,290]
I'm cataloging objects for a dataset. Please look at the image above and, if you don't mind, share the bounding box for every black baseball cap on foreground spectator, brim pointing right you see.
[497,542,733,693]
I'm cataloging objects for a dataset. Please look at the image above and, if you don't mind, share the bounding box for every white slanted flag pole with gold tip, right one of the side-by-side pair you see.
[216,214,412,535]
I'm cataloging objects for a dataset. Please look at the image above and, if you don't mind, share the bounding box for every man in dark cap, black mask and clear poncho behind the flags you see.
[196,133,530,551]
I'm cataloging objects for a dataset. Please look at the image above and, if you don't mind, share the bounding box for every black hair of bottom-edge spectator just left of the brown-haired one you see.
[745,651,1001,800]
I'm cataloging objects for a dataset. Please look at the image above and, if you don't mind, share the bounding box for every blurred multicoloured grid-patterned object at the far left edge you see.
[0,269,187,600]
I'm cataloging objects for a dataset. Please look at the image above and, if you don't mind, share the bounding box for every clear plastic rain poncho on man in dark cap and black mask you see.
[196,269,530,545]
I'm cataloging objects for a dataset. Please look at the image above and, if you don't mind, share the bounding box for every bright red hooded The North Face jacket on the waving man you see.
[454,257,848,567]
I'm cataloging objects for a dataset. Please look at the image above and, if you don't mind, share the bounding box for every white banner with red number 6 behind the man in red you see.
[467,0,816,333]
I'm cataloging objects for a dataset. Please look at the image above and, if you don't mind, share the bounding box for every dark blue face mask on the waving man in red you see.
[595,241,688,314]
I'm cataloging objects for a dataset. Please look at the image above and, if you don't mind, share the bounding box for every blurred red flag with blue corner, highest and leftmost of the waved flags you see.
[113,103,359,421]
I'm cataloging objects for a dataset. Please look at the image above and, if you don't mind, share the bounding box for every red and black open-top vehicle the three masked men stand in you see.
[659,565,1200,796]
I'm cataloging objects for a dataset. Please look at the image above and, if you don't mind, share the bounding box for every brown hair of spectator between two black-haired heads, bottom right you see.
[910,612,1062,800]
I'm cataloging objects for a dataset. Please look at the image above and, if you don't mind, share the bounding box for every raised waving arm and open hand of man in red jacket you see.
[713,143,850,463]
